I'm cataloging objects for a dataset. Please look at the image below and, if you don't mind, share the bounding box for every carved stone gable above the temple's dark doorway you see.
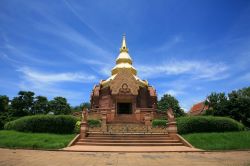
[110,70,139,95]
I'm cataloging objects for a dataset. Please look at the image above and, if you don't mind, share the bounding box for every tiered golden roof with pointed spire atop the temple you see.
[101,35,148,86]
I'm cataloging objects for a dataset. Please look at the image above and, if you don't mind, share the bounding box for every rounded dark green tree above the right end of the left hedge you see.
[48,97,71,115]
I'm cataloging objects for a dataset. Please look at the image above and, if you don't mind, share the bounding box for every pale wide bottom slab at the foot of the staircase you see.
[63,145,202,152]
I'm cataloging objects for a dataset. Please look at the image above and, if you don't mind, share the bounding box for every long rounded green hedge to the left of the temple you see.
[4,115,77,134]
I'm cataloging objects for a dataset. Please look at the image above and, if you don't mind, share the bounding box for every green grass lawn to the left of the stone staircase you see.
[0,130,75,149]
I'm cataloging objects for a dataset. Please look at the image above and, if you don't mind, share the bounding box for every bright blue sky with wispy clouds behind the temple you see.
[0,0,250,110]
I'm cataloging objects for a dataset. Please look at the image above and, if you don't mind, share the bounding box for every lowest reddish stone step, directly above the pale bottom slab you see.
[76,142,183,146]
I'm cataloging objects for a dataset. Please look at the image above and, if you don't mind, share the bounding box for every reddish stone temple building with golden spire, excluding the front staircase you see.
[91,35,157,123]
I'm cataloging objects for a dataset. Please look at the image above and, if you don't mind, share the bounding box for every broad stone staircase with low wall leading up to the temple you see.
[68,109,195,152]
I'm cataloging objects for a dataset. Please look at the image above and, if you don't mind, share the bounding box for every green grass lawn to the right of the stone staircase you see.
[182,131,250,150]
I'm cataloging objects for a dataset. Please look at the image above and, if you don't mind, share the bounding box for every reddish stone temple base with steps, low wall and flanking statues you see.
[70,110,192,148]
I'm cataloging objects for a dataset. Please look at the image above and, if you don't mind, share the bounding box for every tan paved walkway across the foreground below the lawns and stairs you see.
[0,149,250,166]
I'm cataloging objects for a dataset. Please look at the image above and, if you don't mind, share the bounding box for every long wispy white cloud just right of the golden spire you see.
[137,60,228,80]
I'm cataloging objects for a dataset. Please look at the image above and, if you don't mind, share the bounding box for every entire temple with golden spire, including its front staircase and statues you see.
[69,36,192,152]
